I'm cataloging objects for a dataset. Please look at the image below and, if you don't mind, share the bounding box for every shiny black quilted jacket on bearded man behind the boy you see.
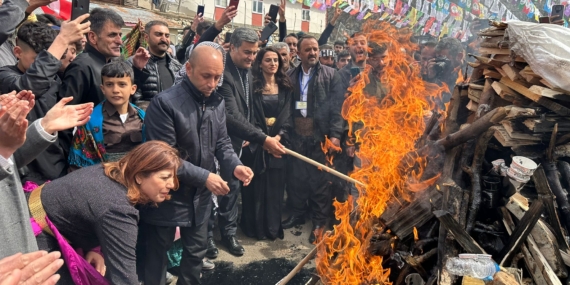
[129,53,182,101]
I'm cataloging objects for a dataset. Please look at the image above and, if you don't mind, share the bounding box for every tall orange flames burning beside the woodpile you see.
[317,22,442,285]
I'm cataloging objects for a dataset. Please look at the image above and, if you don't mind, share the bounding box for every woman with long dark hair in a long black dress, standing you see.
[241,47,293,240]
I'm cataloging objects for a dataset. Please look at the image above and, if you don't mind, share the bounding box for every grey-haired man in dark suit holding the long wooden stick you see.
[214,28,285,256]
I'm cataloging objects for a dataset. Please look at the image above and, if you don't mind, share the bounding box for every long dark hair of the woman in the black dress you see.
[252,47,293,94]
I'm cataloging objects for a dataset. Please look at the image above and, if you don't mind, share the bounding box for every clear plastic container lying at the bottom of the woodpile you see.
[445,257,501,281]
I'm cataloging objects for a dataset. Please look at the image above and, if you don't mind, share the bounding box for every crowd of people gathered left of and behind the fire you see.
[0,0,465,285]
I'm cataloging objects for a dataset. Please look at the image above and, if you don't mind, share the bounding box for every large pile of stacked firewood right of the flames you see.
[364,22,570,285]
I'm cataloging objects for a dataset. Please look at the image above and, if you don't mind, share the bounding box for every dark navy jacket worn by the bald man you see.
[141,77,241,227]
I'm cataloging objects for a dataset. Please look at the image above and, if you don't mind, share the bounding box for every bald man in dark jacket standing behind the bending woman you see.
[140,46,253,285]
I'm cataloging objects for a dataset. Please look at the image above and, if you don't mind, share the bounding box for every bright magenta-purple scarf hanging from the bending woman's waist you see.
[23,182,109,285]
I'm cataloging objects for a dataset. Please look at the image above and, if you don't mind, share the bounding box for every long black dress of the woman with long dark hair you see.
[240,92,291,240]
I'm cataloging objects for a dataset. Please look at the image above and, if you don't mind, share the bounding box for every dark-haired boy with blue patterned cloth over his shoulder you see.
[68,60,145,166]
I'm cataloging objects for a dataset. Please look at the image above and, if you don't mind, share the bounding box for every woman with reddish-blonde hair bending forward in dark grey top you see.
[29,141,180,284]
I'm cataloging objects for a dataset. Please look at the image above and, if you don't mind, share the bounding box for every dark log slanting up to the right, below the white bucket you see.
[497,200,543,266]
